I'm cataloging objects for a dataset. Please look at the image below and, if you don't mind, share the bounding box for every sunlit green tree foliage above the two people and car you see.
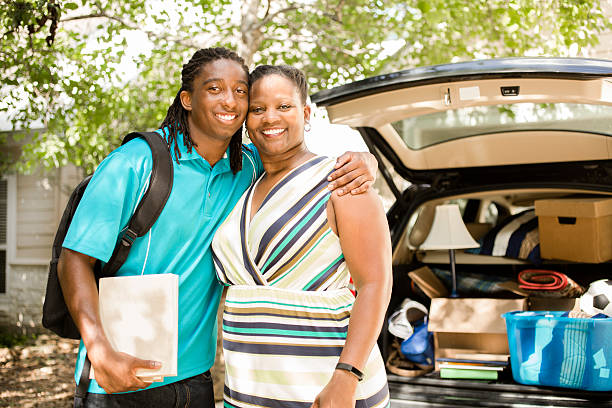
[0,0,610,172]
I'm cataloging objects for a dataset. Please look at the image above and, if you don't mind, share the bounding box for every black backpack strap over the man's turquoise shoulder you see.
[101,132,174,277]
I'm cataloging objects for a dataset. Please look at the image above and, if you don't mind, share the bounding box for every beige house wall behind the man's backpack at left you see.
[0,158,81,333]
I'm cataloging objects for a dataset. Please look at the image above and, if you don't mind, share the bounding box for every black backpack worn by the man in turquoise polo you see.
[42,132,174,338]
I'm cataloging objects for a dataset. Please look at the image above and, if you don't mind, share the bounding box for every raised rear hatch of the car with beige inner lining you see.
[311,58,612,173]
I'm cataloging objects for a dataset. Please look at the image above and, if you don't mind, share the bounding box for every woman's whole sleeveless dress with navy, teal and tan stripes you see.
[213,157,389,408]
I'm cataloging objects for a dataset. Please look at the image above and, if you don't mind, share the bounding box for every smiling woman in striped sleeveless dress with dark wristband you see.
[213,65,391,407]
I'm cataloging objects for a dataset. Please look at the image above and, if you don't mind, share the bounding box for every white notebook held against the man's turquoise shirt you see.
[90,273,178,382]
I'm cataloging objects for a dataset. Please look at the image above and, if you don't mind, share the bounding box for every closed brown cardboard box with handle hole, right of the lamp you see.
[535,198,612,263]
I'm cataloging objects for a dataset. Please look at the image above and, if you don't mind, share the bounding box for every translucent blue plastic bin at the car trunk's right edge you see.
[502,311,612,391]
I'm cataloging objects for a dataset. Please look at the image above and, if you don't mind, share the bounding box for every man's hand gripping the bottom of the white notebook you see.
[88,345,161,394]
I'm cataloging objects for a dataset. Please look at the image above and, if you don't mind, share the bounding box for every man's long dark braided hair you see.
[160,47,249,174]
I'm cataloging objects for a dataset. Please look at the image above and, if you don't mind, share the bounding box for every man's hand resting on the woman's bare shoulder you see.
[327,152,378,196]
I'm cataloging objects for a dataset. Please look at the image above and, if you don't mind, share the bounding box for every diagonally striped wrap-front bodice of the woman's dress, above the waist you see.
[213,157,349,290]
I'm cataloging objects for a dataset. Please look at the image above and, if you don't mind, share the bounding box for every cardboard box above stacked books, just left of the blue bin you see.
[428,298,527,369]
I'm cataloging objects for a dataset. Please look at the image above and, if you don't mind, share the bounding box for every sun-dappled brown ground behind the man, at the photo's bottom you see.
[0,334,223,408]
